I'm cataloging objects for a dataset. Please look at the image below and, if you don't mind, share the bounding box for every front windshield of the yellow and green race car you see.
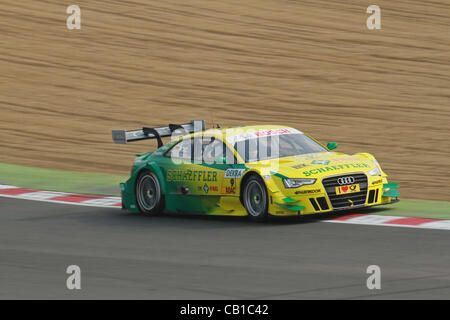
[234,133,328,162]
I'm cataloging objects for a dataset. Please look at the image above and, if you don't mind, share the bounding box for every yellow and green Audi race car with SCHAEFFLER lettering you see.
[112,120,399,220]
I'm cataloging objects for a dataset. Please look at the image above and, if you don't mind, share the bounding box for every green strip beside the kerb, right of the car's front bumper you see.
[368,199,450,220]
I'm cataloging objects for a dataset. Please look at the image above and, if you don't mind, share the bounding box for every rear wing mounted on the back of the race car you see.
[112,120,205,148]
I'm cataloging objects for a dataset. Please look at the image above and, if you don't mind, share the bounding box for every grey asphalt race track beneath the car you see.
[0,198,450,299]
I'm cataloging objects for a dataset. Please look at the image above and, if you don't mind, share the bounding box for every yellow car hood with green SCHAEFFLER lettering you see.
[253,152,377,178]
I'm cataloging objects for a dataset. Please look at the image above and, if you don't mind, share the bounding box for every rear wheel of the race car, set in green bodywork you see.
[135,170,164,215]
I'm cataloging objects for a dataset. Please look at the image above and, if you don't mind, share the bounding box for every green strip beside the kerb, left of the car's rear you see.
[0,163,127,196]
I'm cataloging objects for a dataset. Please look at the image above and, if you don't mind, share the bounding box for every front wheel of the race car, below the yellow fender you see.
[242,175,269,221]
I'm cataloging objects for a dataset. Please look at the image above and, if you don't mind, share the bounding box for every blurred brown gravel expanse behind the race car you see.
[0,0,450,200]
